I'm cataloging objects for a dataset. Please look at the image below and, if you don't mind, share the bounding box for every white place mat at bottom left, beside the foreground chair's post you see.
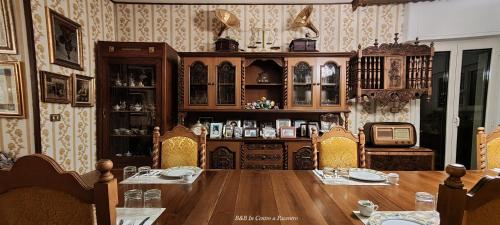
[116,208,165,225]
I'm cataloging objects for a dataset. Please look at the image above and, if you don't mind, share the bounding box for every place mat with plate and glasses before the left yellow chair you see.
[120,166,203,184]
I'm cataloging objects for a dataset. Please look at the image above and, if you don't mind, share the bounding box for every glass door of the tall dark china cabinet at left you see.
[107,64,156,157]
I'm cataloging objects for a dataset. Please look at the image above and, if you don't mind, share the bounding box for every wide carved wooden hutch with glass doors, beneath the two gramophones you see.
[178,52,355,169]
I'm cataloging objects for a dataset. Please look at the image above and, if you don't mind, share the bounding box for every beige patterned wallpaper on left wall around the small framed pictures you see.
[31,0,115,173]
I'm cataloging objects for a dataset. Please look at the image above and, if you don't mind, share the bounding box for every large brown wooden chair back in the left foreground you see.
[0,154,118,225]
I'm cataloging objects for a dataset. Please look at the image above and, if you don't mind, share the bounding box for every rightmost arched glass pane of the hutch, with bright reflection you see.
[320,62,340,105]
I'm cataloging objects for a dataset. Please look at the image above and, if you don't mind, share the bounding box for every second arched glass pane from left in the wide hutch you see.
[217,61,236,105]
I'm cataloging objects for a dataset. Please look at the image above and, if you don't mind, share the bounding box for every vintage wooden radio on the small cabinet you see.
[365,122,417,147]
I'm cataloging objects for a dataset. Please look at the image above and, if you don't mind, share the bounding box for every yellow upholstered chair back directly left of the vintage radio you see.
[312,127,366,169]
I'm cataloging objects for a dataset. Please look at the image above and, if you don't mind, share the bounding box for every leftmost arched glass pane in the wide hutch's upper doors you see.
[189,61,208,105]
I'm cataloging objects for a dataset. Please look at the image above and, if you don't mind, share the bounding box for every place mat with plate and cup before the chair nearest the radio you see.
[313,167,399,185]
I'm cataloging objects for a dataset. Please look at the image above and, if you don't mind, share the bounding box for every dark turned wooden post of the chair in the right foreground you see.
[437,164,467,225]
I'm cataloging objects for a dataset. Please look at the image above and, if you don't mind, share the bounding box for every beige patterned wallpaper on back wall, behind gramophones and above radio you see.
[115,4,420,132]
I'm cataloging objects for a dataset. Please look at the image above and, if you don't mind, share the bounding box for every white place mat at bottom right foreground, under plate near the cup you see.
[352,211,440,225]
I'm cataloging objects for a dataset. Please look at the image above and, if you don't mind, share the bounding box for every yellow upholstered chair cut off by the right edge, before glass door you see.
[476,125,500,170]
